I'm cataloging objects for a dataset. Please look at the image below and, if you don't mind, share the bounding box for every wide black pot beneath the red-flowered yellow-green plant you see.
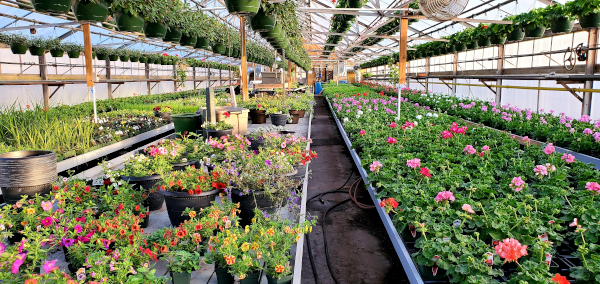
[160,189,221,227]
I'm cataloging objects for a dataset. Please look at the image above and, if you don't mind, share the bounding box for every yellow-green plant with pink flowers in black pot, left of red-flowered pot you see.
[119,153,173,211]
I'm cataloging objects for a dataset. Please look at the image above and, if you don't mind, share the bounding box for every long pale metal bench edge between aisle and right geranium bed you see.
[327,100,424,284]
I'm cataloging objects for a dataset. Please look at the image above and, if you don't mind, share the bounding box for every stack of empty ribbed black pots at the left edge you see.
[0,151,58,204]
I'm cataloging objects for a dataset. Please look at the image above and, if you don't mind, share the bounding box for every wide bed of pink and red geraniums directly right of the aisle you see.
[324,85,600,283]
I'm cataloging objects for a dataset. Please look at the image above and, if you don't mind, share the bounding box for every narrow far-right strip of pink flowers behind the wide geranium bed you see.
[356,83,600,158]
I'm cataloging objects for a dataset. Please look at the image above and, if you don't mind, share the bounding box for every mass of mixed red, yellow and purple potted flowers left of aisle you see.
[0,123,316,284]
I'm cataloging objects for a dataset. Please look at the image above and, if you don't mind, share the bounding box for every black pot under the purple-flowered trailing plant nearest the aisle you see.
[231,189,276,228]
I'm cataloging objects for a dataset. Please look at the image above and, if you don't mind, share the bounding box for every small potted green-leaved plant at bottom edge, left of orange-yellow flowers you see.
[161,250,201,284]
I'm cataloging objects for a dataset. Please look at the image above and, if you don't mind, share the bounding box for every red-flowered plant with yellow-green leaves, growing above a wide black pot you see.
[158,166,229,195]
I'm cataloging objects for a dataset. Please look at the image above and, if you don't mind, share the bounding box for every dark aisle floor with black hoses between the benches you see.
[302,96,409,284]
